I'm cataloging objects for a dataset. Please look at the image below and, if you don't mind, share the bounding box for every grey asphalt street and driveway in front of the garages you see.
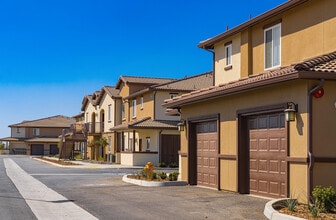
[0,156,268,219]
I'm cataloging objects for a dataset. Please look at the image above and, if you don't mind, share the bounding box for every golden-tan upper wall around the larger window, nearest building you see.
[251,0,336,74]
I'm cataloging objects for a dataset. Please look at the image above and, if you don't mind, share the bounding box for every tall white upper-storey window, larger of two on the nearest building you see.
[264,24,281,69]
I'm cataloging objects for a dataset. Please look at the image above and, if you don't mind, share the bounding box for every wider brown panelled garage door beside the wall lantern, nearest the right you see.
[249,113,287,198]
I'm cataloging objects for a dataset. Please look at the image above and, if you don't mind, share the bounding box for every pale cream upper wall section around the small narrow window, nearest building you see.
[214,34,241,85]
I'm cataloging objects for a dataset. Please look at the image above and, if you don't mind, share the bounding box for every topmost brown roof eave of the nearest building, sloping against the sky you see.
[198,0,309,49]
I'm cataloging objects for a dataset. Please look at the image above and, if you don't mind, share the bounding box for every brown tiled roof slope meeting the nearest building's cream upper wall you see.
[125,72,213,99]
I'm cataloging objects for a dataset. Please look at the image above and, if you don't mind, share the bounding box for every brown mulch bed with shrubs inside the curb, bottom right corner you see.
[278,204,336,220]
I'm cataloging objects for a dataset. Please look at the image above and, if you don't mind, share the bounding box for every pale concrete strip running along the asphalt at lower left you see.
[4,158,97,220]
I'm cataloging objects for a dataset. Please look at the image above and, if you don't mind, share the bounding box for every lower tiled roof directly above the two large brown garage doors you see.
[163,51,336,108]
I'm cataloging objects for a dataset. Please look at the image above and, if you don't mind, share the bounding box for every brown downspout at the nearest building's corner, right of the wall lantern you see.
[307,79,325,198]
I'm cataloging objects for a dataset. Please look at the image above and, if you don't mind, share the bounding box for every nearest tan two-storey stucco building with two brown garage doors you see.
[164,0,336,201]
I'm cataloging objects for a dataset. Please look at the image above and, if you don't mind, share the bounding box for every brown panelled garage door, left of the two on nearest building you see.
[196,121,218,189]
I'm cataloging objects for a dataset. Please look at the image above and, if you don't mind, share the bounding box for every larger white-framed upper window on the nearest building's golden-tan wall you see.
[264,23,281,70]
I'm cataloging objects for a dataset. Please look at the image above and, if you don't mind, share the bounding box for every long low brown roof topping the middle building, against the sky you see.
[116,76,175,89]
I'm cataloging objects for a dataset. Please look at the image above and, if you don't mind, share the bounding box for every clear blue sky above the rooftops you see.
[0,0,286,137]
